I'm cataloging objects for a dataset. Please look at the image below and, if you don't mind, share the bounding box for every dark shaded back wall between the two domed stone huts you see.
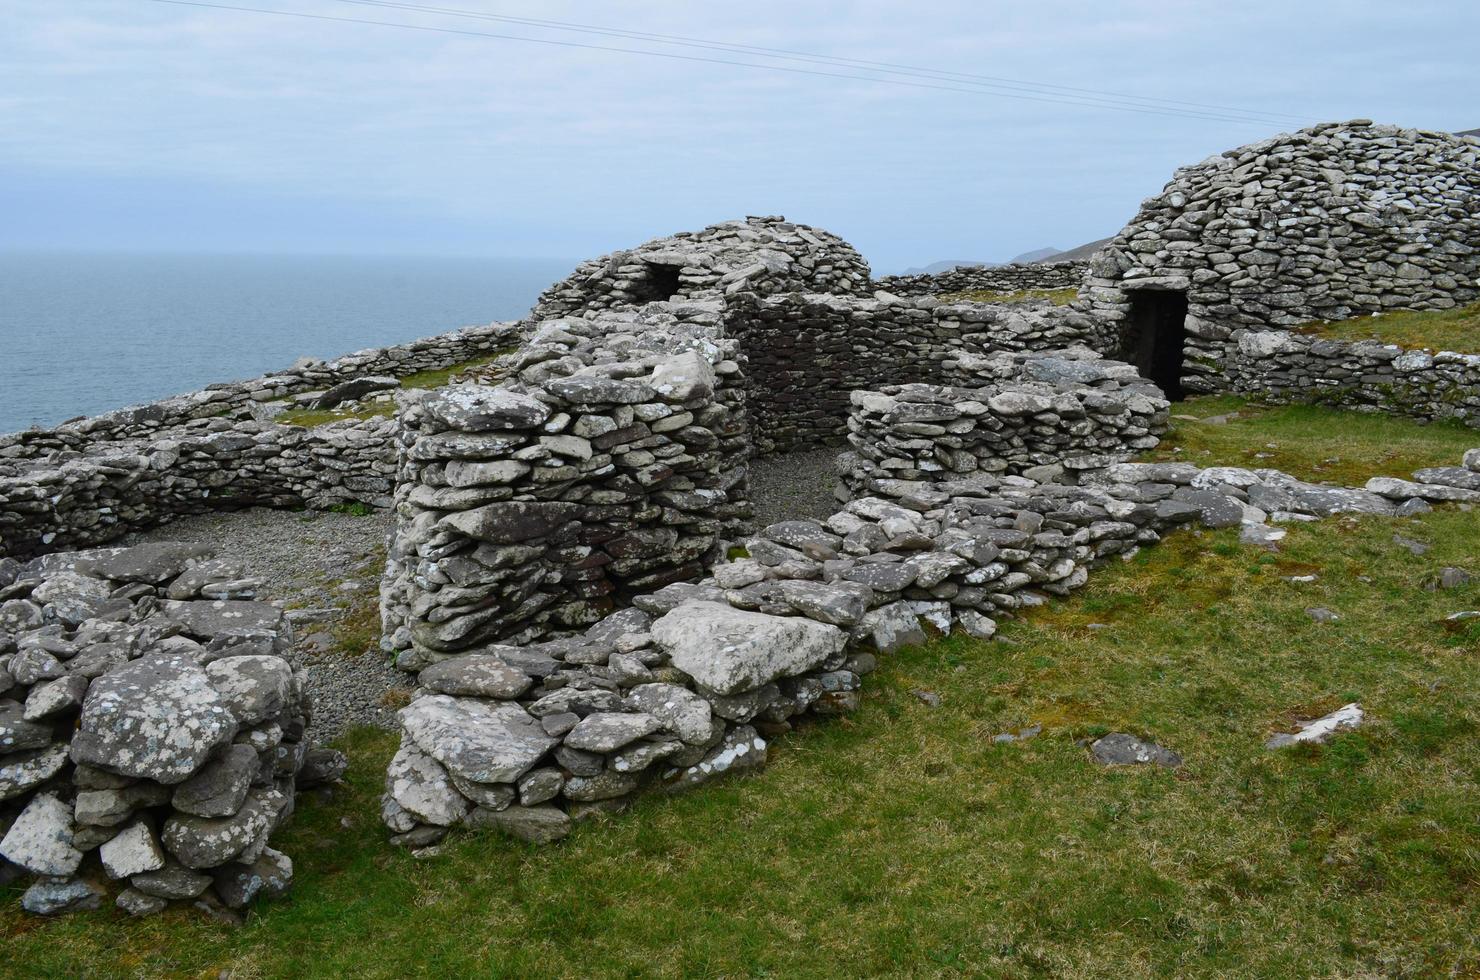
[725,292,1101,454]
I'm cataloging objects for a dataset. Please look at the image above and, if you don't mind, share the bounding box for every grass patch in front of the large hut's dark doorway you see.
[1143,397,1480,487]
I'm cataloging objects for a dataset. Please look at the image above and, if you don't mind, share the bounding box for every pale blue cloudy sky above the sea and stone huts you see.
[0,0,1480,272]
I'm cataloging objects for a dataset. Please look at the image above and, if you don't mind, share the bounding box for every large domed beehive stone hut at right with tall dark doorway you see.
[1080,120,1480,397]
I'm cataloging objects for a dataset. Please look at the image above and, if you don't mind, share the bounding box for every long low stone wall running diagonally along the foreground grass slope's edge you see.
[382,450,1480,847]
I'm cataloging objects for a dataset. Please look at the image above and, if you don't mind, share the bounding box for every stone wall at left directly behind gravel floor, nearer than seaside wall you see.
[0,419,395,558]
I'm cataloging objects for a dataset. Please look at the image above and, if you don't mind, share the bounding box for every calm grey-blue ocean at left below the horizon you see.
[0,252,577,432]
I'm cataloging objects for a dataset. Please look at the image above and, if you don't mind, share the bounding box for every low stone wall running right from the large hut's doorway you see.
[1185,330,1480,428]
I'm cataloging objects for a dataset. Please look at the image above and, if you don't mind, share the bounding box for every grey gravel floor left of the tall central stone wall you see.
[123,508,411,742]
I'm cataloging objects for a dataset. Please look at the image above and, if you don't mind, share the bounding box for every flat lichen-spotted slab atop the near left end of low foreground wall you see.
[400,694,559,783]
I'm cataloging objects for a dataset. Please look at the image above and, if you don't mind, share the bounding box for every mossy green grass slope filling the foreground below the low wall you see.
[0,402,1480,977]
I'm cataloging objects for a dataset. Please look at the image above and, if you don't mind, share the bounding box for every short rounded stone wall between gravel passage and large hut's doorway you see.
[839,349,1169,494]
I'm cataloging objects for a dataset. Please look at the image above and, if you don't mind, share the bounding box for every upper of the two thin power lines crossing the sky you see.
[336,0,1308,121]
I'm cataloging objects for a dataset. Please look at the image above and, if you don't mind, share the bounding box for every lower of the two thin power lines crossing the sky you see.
[136,0,1296,124]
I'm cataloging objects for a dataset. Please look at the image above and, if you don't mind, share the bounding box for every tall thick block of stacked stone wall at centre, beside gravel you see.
[382,303,749,669]
